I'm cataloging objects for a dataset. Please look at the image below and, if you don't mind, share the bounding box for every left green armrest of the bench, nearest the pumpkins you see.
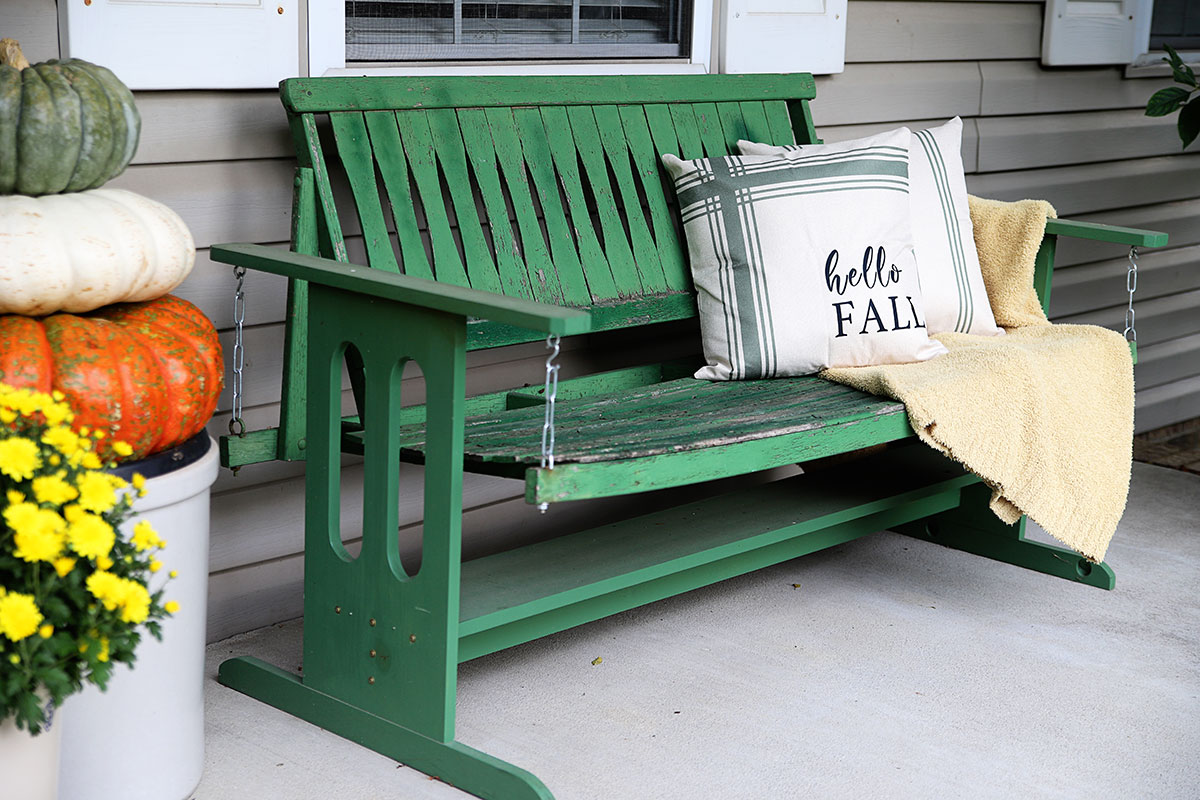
[211,239,592,336]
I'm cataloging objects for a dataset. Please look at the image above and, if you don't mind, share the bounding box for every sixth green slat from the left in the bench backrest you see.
[485,108,563,302]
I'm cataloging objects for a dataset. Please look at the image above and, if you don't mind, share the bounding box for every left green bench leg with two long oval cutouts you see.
[218,287,553,800]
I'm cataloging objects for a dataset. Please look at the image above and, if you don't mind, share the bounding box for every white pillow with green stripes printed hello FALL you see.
[662,128,946,380]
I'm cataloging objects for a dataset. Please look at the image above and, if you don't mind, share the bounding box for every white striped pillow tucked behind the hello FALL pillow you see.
[738,116,1004,336]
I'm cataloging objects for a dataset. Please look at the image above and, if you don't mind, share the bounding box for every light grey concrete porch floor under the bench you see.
[193,464,1200,800]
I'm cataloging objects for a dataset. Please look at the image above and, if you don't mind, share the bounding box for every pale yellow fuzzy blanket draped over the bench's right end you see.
[821,198,1133,561]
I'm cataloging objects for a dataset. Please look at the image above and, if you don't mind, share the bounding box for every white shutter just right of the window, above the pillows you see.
[720,0,846,74]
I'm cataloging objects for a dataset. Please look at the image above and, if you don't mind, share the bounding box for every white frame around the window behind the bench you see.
[308,0,714,76]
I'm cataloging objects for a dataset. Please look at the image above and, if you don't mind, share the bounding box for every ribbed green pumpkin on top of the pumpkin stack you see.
[0,38,142,196]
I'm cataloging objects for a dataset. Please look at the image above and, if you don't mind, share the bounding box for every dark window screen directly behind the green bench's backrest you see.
[346,0,691,61]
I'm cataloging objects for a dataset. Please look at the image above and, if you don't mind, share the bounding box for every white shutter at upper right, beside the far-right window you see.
[1042,0,1153,66]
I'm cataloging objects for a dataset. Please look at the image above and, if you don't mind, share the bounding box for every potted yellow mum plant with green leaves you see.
[0,384,178,734]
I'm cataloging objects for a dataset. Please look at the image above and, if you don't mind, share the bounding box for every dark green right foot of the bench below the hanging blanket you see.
[895,483,1116,589]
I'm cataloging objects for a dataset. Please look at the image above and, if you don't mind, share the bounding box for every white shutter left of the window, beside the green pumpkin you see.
[59,0,300,89]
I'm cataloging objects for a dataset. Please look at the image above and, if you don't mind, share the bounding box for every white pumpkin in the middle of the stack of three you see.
[0,188,196,317]
